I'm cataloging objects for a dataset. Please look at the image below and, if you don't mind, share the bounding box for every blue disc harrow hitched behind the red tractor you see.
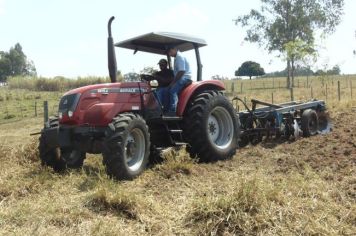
[233,97,331,147]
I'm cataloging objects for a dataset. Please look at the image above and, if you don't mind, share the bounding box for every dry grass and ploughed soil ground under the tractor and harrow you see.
[0,109,356,235]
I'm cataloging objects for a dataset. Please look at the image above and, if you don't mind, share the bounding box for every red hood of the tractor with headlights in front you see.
[58,82,150,126]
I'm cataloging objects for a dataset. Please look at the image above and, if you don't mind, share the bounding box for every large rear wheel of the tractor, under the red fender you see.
[183,91,240,162]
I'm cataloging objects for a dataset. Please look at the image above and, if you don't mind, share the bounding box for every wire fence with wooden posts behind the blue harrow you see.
[225,76,356,105]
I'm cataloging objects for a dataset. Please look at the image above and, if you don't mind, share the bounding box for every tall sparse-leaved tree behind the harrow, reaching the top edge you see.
[235,0,344,88]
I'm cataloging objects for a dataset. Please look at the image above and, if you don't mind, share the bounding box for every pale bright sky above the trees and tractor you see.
[0,0,356,79]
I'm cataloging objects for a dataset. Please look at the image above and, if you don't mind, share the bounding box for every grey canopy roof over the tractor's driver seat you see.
[115,32,207,55]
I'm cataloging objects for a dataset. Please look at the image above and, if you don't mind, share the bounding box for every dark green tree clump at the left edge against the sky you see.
[0,43,37,81]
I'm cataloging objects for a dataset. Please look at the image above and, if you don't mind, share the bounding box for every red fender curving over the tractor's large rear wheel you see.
[177,80,225,116]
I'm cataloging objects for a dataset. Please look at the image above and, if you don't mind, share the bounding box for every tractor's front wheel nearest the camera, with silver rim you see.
[103,113,150,180]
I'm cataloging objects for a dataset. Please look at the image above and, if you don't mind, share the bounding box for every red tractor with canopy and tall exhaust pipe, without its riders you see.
[39,17,239,179]
